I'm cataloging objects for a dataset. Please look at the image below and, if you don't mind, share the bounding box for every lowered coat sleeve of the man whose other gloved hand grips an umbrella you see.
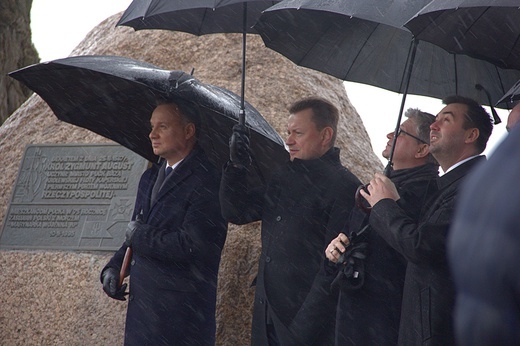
[289,177,359,345]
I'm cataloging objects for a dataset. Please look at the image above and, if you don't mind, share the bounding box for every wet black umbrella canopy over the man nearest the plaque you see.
[9,56,288,178]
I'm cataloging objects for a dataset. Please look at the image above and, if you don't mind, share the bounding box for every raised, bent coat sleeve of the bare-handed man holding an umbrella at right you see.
[370,199,453,263]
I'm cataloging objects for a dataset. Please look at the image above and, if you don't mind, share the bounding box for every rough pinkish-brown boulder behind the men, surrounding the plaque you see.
[0,15,382,345]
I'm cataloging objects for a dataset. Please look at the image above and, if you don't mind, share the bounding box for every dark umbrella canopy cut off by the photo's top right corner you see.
[405,0,520,71]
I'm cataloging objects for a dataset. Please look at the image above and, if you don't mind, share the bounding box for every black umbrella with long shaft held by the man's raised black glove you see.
[117,0,278,124]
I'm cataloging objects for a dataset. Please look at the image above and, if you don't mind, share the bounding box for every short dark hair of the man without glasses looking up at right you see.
[442,95,493,154]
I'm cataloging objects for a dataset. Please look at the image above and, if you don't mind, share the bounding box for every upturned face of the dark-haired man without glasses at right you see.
[430,103,468,161]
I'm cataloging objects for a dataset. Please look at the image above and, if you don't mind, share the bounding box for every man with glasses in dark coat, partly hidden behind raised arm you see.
[325,108,439,346]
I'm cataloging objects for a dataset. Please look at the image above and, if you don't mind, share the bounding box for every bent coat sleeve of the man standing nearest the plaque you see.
[132,176,227,263]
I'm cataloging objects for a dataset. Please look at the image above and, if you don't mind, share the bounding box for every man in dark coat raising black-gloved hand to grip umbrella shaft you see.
[221,97,360,346]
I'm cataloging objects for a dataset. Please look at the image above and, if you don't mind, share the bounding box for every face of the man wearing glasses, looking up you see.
[382,119,425,169]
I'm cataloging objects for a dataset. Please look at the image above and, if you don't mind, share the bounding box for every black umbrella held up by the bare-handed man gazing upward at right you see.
[254,0,520,172]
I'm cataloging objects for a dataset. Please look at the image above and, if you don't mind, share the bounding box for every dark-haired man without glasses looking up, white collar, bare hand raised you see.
[361,96,493,345]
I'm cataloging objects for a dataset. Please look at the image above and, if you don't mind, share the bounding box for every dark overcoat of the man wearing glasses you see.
[336,164,438,346]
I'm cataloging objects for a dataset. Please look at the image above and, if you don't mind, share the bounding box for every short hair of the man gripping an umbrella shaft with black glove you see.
[289,96,339,147]
